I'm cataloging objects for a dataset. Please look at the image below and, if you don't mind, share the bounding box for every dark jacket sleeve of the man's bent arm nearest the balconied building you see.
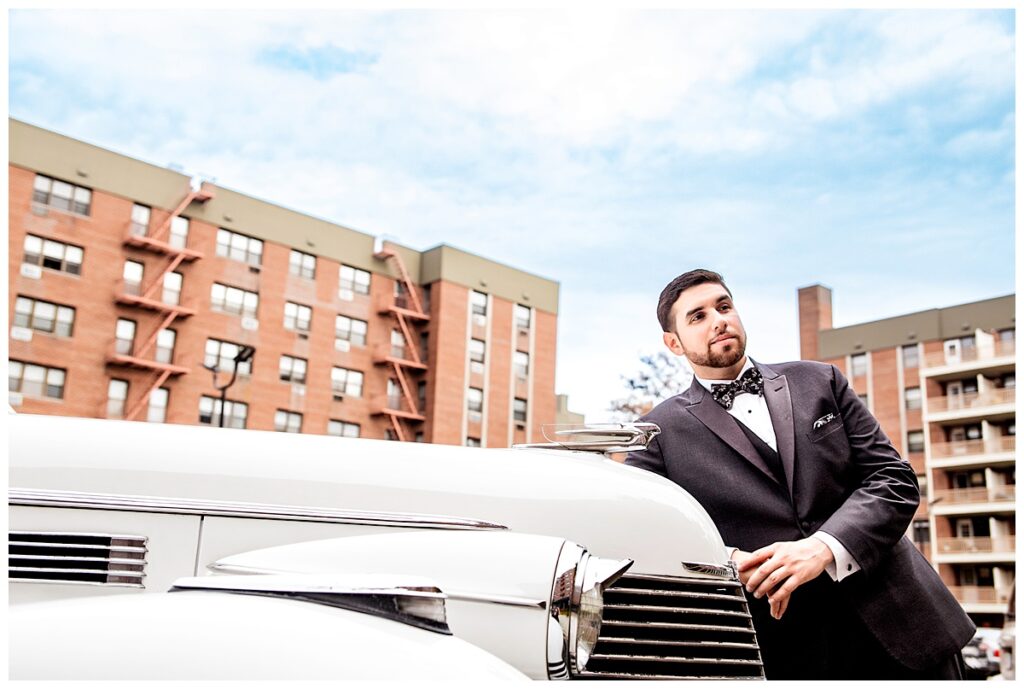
[819,365,921,573]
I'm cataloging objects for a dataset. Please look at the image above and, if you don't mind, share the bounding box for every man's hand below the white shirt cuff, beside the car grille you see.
[734,537,834,619]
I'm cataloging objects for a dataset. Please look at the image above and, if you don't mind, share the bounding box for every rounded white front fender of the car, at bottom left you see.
[8,591,526,682]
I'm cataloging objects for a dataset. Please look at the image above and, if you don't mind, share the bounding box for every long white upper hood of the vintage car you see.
[8,415,727,574]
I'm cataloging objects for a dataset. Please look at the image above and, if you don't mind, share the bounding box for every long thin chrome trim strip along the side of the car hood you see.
[14,488,508,529]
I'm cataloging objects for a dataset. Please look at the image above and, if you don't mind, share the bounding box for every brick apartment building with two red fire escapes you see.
[8,120,558,447]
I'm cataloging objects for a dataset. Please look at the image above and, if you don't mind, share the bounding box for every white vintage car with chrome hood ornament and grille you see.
[8,415,763,680]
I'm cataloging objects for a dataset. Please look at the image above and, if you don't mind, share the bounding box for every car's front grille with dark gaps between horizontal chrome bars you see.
[581,573,764,680]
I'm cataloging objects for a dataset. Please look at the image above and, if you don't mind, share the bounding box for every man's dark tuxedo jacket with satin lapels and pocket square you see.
[626,361,975,670]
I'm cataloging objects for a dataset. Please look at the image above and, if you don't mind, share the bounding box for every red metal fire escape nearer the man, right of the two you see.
[374,240,430,440]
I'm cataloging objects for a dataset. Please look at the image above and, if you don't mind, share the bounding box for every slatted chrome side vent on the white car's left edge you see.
[7,531,146,588]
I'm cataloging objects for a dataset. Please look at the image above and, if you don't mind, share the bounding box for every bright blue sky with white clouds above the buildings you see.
[9,9,1016,421]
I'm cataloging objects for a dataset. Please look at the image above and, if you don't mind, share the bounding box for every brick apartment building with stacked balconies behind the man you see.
[798,285,1016,627]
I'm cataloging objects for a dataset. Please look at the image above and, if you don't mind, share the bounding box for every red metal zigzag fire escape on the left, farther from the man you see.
[106,182,214,421]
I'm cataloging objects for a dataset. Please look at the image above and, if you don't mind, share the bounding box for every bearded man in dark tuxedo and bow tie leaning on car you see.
[626,269,975,680]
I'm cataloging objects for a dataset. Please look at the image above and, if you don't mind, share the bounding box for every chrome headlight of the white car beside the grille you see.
[548,542,633,679]
